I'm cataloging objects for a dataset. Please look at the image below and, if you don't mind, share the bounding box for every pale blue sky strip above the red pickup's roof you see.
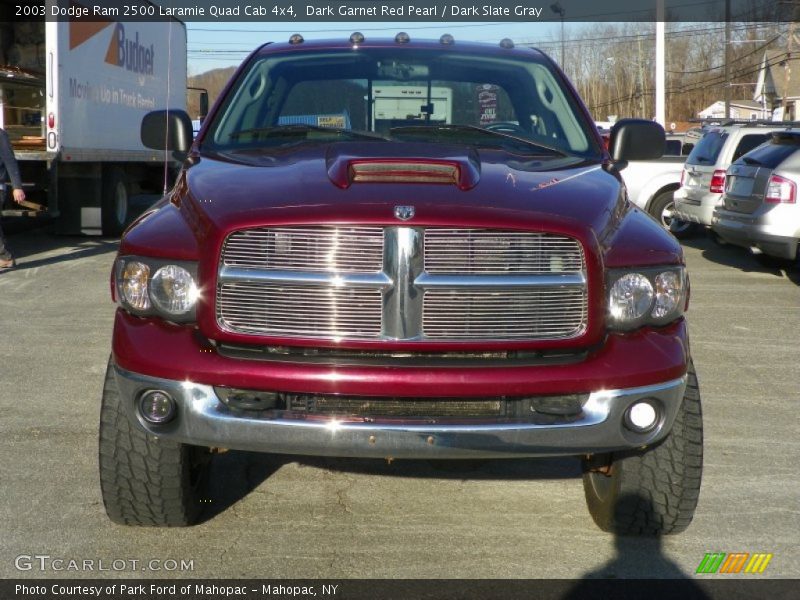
[186,21,572,75]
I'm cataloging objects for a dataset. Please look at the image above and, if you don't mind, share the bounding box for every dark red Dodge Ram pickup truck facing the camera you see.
[100,34,702,535]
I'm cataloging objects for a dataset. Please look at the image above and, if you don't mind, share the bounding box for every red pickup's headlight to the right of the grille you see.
[607,266,689,331]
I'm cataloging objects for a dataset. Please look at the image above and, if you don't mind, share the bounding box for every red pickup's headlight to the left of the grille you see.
[116,256,200,323]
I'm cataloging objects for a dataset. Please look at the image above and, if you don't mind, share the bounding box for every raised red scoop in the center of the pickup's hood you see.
[327,144,480,190]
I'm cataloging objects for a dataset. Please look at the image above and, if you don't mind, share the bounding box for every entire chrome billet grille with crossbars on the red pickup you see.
[216,226,588,342]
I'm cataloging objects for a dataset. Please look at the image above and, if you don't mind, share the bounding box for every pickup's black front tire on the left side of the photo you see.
[100,360,210,527]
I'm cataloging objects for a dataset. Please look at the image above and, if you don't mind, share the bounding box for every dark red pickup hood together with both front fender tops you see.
[120,142,683,266]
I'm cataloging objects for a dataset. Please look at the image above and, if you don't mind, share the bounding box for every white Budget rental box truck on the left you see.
[0,0,186,235]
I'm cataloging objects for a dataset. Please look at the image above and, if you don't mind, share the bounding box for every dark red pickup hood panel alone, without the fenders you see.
[185,142,620,237]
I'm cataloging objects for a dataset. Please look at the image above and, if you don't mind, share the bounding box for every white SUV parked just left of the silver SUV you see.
[672,121,786,233]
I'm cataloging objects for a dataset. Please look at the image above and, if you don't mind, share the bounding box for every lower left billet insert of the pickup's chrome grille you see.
[217,282,381,338]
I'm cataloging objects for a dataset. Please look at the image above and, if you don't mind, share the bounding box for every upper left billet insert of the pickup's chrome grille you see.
[223,227,383,273]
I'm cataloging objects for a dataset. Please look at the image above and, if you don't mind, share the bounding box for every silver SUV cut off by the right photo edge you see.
[712,129,800,260]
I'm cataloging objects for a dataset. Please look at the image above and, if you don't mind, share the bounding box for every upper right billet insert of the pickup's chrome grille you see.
[425,229,583,275]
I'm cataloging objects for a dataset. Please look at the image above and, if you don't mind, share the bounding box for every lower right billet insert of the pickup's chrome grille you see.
[422,288,586,340]
